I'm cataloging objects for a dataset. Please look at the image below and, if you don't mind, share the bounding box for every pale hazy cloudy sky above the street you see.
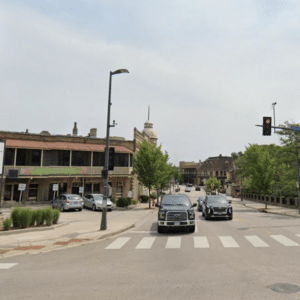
[0,0,300,165]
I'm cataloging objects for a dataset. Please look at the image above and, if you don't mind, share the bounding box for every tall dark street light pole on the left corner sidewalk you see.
[100,69,129,230]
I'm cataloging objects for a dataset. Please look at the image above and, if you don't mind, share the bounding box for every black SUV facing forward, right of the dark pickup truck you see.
[202,195,233,220]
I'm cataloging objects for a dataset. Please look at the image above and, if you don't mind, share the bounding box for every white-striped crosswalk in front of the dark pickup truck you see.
[105,234,300,250]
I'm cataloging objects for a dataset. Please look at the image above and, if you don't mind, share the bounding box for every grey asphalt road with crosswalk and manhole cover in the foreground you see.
[0,189,300,300]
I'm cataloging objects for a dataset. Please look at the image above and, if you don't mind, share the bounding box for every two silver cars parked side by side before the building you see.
[51,194,113,211]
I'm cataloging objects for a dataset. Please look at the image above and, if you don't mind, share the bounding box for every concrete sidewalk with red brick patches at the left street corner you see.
[0,203,157,258]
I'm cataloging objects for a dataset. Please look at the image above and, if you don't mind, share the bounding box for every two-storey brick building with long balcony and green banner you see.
[0,123,157,204]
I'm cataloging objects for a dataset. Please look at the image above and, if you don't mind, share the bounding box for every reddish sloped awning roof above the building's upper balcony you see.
[6,139,133,153]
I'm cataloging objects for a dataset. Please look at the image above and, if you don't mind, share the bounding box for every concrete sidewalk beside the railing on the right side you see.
[226,196,300,218]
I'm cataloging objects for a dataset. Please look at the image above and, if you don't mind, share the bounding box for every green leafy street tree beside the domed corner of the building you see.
[133,140,173,208]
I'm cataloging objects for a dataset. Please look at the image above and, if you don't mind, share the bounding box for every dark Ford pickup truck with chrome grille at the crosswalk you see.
[155,194,197,233]
